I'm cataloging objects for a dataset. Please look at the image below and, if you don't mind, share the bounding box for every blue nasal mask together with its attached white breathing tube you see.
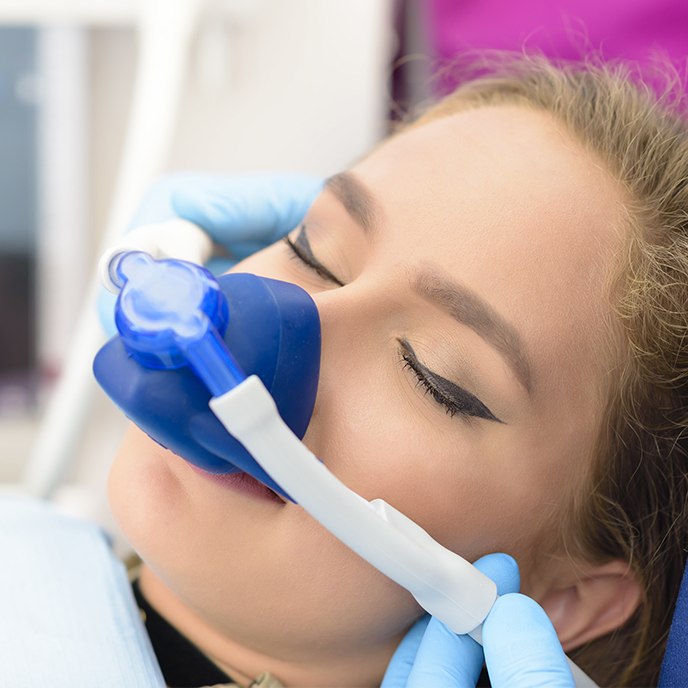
[94,221,590,685]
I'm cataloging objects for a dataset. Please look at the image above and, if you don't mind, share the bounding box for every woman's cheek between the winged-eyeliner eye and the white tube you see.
[305,354,564,560]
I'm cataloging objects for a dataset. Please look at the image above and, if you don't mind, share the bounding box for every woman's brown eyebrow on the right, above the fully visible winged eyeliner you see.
[413,267,532,395]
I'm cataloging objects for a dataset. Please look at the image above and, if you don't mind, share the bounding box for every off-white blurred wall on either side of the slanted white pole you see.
[91,0,394,239]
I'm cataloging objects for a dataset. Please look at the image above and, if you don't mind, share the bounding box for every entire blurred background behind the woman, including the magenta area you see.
[0,0,688,523]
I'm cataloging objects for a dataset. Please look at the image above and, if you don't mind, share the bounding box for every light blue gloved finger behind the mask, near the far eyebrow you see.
[172,174,323,250]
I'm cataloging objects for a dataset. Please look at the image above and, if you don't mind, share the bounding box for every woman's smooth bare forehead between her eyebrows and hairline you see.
[353,106,623,400]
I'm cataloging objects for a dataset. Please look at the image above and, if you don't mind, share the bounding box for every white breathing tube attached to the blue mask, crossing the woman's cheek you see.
[99,220,596,688]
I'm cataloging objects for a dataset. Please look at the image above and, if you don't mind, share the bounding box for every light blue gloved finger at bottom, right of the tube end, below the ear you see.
[483,594,574,688]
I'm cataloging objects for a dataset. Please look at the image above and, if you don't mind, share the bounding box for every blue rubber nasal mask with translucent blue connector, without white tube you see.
[93,252,320,496]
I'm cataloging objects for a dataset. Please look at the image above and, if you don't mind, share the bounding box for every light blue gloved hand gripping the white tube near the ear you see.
[381,554,574,688]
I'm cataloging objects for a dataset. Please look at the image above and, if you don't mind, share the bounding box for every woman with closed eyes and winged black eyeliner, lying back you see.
[110,59,688,686]
